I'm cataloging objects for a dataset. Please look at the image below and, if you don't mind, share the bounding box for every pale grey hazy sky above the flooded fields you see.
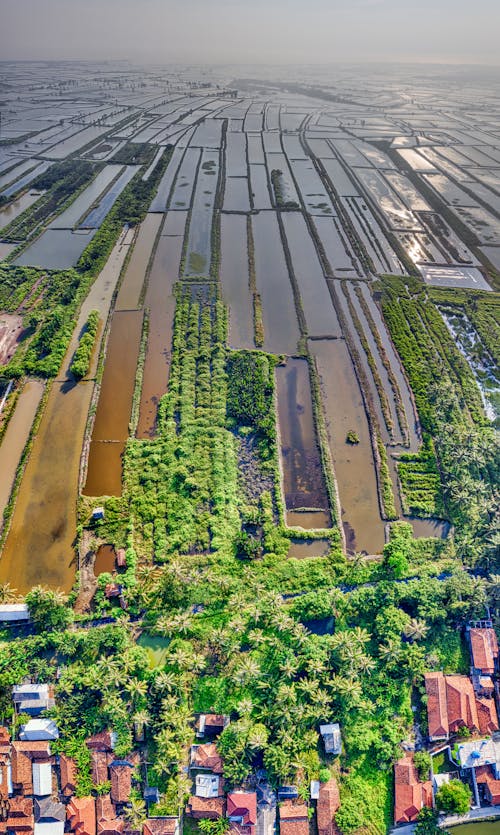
[0,0,500,65]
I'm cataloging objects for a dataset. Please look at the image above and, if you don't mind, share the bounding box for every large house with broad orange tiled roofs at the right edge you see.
[425,672,499,742]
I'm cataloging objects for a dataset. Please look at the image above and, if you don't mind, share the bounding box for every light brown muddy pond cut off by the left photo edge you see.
[0,380,45,528]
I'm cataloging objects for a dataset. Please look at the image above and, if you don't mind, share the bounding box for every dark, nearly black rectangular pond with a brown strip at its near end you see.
[276,359,330,528]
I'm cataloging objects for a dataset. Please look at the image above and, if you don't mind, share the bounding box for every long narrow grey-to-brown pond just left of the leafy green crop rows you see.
[137,212,187,438]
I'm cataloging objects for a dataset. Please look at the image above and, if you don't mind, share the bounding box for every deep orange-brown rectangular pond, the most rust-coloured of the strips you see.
[83,310,143,496]
